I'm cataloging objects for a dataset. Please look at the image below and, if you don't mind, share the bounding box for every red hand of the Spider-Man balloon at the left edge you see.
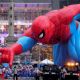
[0,48,14,67]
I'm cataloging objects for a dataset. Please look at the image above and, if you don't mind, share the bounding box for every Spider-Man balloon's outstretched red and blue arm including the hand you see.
[0,27,36,66]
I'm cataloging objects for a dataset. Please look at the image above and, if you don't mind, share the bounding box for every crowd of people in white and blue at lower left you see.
[0,65,41,80]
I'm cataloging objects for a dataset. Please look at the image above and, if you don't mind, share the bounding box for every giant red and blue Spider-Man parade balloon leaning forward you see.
[0,4,80,66]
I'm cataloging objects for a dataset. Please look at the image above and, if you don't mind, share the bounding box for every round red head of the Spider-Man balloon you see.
[32,16,55,44]
